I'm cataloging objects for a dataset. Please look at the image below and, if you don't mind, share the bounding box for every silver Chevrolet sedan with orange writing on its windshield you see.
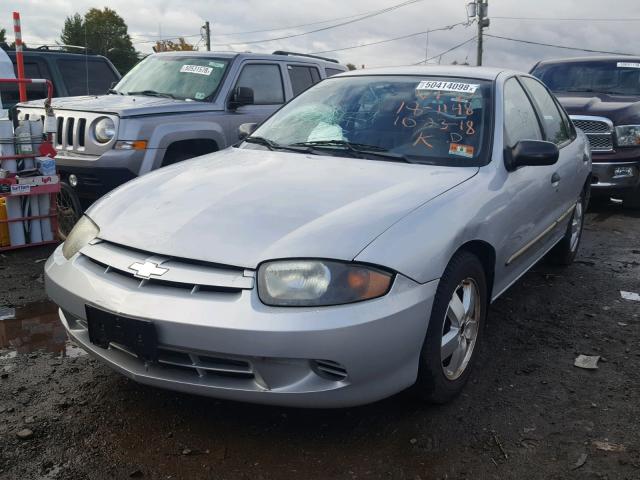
[45,66,591,407]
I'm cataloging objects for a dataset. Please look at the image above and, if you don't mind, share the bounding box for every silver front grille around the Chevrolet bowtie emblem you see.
[77,241,254,294]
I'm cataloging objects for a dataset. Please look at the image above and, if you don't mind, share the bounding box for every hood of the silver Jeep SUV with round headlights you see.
[20,95,222,117]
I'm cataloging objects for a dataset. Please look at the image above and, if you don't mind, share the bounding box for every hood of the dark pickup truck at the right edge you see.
[556,92,640,125]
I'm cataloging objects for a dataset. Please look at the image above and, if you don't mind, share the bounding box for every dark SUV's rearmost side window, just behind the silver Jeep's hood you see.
[57,57,118,96]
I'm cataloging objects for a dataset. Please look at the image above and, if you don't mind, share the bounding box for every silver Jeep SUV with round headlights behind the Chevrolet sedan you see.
[18,51,347,230]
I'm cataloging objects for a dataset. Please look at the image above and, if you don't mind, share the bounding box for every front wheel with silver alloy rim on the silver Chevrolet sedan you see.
[416,251,489,404]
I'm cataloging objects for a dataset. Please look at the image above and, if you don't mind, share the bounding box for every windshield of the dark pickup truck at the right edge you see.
[532,61,640,96]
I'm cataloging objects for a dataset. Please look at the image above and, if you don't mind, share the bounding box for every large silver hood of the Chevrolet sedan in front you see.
[87,148,478,268]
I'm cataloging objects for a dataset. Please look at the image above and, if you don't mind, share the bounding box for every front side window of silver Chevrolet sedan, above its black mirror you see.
[504,78,542,147]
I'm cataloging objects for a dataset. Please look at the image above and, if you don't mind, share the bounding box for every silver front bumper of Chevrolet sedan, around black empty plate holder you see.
[45,248,437,407]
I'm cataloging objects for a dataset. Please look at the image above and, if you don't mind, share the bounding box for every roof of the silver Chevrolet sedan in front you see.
[336,65,516,81]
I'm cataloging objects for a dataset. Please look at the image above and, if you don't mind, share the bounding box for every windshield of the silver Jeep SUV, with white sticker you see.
[114,55,229,101]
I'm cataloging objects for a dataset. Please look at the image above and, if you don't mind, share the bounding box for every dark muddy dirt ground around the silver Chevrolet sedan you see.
[0,205,640,480]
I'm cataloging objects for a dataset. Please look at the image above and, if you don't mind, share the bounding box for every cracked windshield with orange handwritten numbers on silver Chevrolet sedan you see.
[242,76,491,166]
